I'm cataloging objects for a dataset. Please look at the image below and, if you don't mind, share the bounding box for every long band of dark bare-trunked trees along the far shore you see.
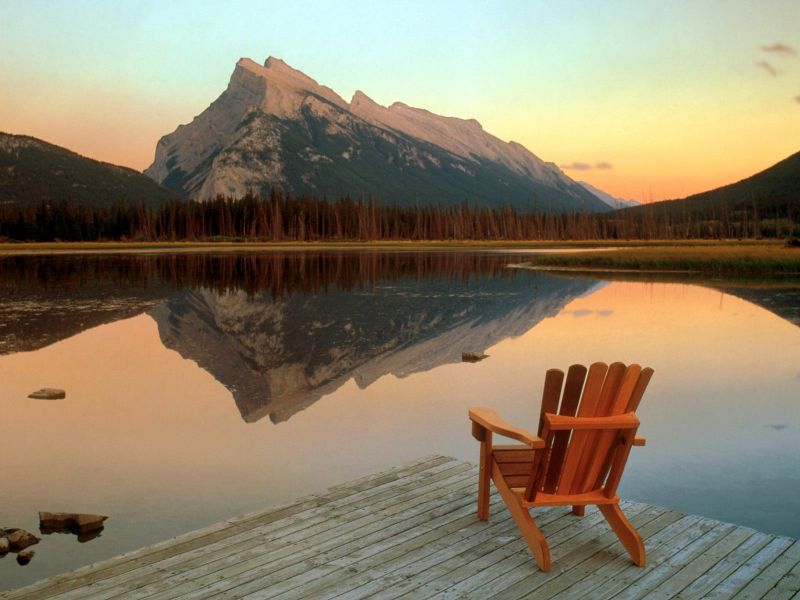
[0,190,800,242]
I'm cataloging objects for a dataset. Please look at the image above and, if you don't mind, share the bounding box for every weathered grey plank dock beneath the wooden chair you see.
[0,457,800,600]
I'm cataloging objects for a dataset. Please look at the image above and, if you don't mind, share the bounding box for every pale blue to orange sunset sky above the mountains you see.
[0,0,800,202]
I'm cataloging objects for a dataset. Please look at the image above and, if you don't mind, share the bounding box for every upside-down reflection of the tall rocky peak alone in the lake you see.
[150,276,595,423]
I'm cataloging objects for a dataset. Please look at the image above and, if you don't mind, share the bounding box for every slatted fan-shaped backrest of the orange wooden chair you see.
[525,363,653,502]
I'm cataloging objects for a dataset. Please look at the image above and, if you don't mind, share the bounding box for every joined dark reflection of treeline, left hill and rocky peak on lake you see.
[0,252,598,423]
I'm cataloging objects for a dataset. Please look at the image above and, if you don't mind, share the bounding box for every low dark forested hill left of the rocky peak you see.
[0,132,180,207]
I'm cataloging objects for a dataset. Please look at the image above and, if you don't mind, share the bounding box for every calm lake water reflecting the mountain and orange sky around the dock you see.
[0,252,800,589]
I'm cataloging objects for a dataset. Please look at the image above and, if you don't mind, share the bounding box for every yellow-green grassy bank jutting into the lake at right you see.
[527,242,800,276]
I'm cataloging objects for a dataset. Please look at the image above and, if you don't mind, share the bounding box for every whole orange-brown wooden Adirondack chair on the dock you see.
[469,363,653,571]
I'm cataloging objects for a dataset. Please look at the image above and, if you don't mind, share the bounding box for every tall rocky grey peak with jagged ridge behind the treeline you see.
[145,57,608,212]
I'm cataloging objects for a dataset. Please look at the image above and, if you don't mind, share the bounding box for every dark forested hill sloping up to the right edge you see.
[615,152,800,218]
